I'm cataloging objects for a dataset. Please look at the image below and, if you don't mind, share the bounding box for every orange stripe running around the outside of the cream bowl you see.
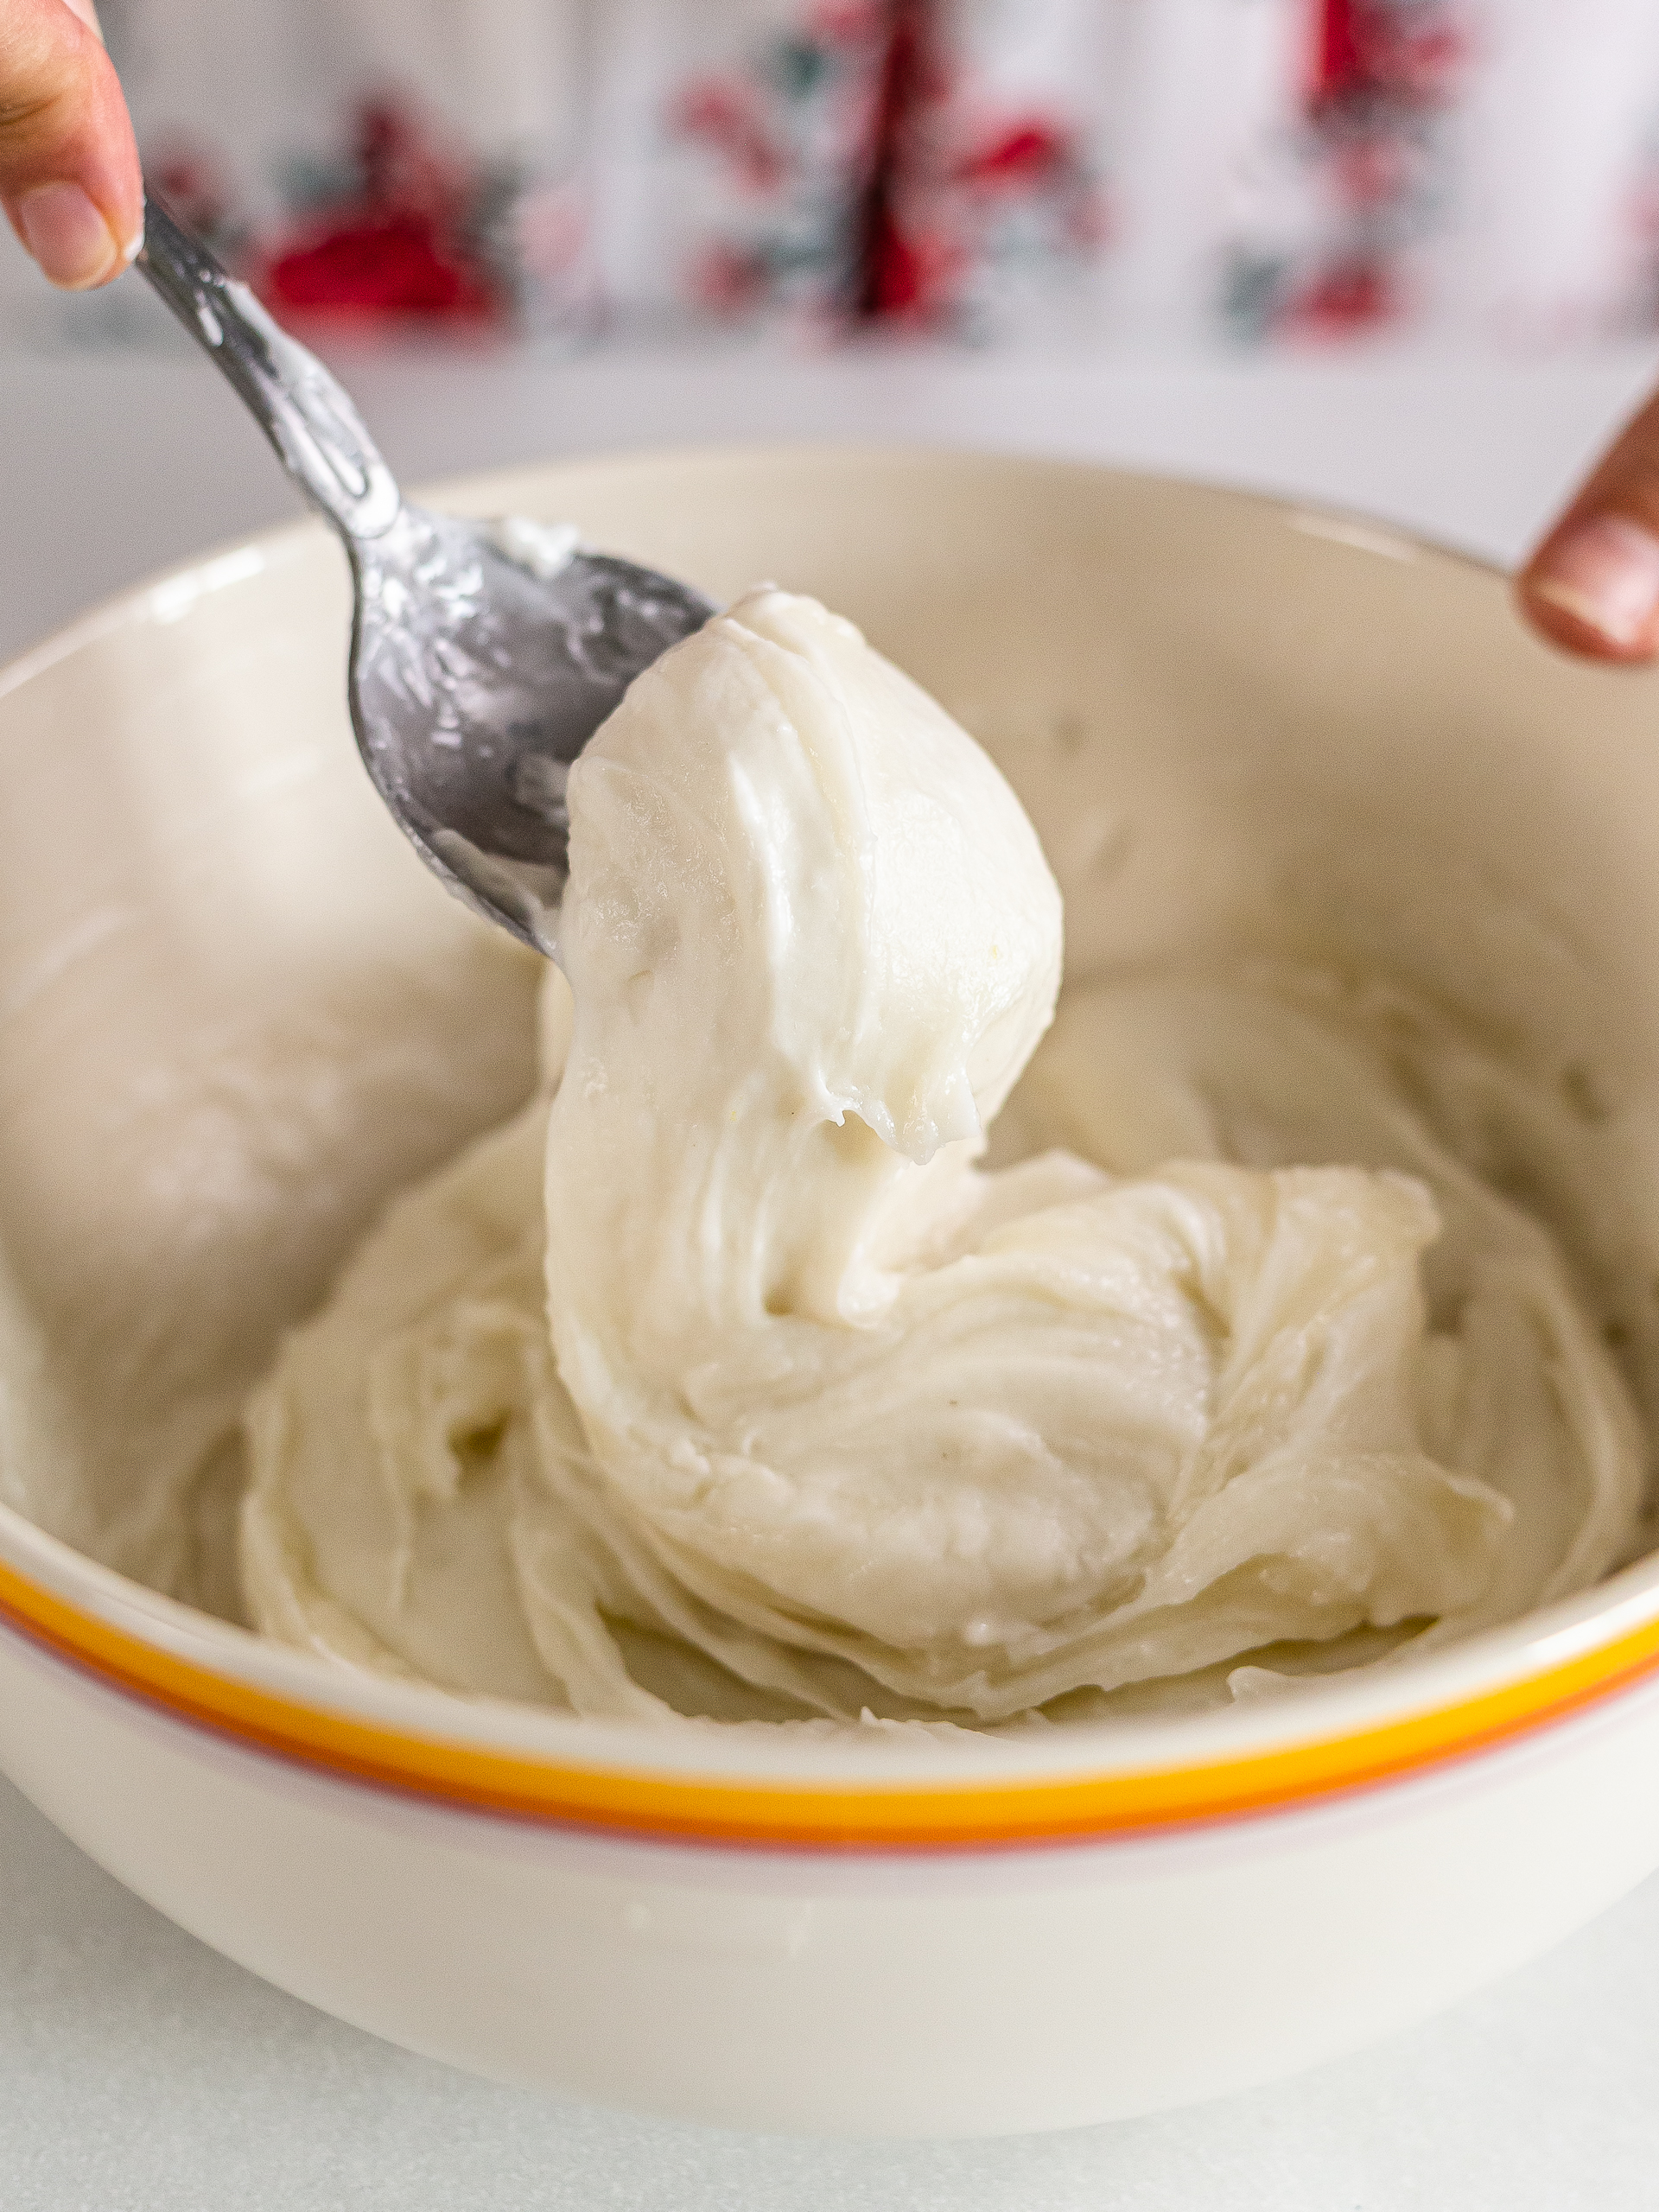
[0,1564,1659,1852]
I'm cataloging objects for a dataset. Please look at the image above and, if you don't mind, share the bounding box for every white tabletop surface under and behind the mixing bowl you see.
[0,281,1659,2212]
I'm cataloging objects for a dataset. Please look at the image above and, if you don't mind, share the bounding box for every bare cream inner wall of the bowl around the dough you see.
[0,451,1659,1760]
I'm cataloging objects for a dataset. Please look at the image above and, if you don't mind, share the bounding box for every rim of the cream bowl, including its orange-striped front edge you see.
[0,442,1659,1852]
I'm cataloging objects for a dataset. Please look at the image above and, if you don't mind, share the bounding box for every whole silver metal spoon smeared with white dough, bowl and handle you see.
[137,199,715,953]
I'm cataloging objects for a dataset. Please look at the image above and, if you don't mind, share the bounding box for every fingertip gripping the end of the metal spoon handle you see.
[0,0,143,292]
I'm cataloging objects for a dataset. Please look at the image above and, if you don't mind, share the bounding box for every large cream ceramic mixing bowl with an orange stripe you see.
[0,451,1659,2133]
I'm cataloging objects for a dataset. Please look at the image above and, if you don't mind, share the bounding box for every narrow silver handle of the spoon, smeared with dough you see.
[137,194,403,544]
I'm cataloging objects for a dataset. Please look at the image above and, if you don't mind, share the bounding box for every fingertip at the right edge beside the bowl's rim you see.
[1516,394,1659,661]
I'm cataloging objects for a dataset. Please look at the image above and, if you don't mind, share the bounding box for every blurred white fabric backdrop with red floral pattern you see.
[7,0,1659,352]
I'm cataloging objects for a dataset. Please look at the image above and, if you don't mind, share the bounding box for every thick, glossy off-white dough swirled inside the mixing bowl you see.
[244,591,1643,1727]
